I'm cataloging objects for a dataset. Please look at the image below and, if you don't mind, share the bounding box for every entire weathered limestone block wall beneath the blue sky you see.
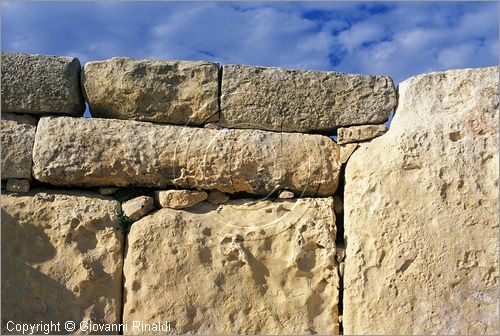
[1,53,498,334]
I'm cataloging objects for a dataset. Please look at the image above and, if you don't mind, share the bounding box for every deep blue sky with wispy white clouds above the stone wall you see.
[2,1,498,82]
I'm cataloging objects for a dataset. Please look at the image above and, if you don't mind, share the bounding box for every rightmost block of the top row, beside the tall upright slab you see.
[220,65,396,132]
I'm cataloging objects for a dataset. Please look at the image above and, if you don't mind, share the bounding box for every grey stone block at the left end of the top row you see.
[2,52,85,117]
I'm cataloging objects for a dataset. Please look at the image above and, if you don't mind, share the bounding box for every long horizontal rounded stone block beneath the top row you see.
[33,117,340,196]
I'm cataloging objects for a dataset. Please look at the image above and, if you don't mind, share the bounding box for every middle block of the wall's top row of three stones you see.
[82,58,218,125]
